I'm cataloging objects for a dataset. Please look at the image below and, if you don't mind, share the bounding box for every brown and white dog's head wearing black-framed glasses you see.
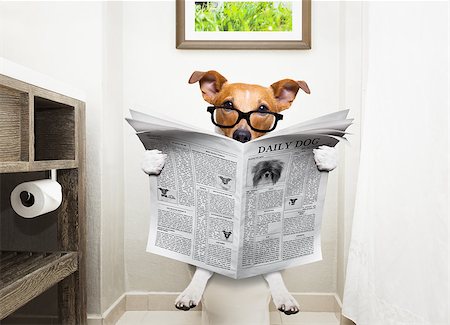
[189,70,310,142]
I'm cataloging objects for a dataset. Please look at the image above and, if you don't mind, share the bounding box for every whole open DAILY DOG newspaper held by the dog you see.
[127,110,352,279]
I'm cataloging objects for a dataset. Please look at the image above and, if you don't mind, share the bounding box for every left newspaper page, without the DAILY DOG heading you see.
[135,132,242,278]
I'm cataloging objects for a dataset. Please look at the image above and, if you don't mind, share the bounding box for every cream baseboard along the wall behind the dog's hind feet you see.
[88,292,342,325]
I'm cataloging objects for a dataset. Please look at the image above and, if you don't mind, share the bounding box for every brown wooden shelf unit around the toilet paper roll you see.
[0,74,87,324]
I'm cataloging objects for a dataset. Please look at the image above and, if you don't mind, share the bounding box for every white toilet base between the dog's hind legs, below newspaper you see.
[202,273,271,325]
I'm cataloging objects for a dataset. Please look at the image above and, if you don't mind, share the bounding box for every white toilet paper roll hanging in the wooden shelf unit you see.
[11,179,62,218]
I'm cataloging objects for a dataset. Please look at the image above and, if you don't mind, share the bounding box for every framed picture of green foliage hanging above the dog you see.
[176,0,311,50]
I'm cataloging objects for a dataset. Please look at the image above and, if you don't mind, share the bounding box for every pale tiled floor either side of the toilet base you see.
[117,311,339,325]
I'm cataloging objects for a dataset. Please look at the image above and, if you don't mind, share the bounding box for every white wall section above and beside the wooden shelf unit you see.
[0,2,124,314]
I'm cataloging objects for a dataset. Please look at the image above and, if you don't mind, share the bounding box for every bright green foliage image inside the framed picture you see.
[195,1,292,32]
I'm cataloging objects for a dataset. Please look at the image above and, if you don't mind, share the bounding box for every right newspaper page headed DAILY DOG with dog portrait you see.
[238,135,338,278]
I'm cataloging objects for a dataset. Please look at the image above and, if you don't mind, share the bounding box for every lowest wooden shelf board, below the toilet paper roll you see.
[0,252,78,319]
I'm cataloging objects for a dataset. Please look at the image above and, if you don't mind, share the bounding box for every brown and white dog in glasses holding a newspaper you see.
[142,70,337,315]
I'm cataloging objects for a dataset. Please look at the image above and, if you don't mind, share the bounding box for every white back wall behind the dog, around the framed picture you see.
[123,1,360,292]
